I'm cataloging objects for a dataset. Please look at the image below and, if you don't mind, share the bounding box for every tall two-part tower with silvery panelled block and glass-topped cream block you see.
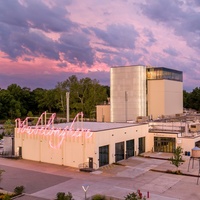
[110,65,183,122]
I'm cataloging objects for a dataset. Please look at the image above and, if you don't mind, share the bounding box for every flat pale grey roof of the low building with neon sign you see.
[50,122,142,132]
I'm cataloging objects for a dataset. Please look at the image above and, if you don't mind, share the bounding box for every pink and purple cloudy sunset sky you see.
[0,0,200,92]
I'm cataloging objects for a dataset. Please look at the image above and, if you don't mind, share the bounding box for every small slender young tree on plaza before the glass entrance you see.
[170,146,184,173]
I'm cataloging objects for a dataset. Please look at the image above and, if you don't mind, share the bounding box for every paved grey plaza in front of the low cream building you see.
[0,153,200,200]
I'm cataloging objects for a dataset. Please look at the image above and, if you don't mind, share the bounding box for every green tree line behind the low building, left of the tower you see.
[0,75,110,120]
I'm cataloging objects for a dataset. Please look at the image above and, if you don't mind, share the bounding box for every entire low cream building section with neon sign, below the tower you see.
[14,111,200,169]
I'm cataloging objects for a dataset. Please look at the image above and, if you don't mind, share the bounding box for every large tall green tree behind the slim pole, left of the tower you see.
[56,75,109,118]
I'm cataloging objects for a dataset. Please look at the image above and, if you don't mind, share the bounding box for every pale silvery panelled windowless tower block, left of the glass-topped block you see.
[110,65,147,122]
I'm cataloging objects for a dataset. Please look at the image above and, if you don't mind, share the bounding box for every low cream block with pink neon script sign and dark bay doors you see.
[15,111,150,169]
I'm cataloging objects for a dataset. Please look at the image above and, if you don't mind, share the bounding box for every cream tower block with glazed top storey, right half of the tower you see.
[147,67,183,119]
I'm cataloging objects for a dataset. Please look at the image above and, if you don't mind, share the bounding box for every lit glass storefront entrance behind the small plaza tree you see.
[154,137,176,153]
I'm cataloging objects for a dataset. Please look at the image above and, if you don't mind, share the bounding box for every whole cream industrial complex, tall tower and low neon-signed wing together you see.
[12,65,200,169]
